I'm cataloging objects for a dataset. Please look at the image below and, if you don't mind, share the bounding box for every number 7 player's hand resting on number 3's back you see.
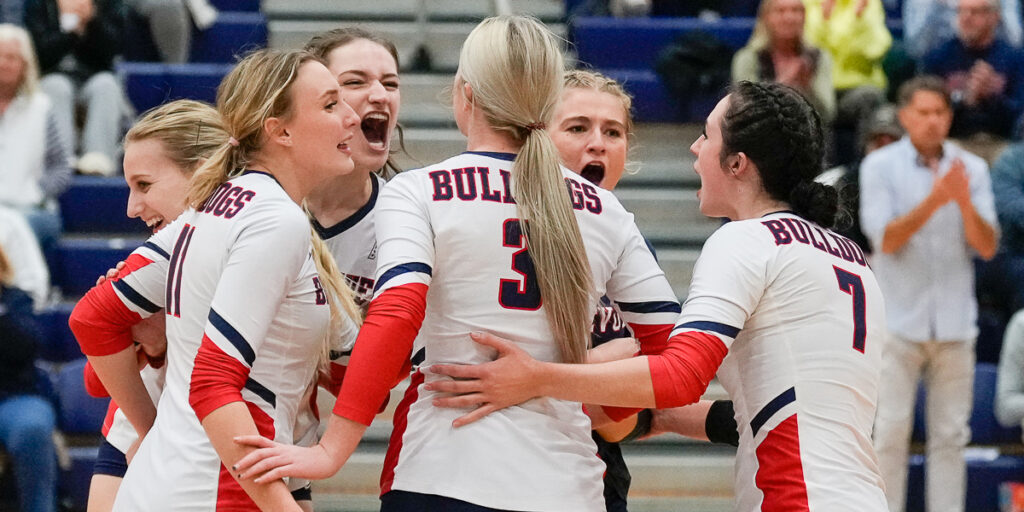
[424,333,541,427]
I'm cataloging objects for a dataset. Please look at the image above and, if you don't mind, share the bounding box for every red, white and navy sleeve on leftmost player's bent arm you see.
[68,223,178,356]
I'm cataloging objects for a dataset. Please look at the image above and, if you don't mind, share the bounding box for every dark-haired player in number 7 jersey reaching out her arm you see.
[425,82,887,511]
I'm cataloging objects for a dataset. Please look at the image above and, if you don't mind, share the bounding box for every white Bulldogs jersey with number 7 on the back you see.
[673,212,887,512]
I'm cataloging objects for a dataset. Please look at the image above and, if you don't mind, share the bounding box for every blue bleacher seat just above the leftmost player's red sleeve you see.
[50,237,145,296]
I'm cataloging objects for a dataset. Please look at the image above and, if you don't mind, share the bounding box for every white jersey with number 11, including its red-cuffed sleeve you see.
[114,172,330,511]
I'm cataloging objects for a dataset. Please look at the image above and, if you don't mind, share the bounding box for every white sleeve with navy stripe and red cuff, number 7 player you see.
[648,222,776,409]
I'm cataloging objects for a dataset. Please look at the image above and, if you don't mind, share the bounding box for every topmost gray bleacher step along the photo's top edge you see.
[262,0,565,23]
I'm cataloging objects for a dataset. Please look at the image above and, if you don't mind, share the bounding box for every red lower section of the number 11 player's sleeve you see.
[188,334,246,422]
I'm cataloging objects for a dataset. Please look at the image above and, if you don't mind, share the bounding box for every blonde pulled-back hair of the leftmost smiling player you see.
[125,99,227,175]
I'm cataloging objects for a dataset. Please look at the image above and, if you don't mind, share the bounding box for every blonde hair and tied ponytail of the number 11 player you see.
[185,49,319,209]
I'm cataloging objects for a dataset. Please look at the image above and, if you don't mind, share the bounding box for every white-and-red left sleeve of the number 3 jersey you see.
[334,173,434,425]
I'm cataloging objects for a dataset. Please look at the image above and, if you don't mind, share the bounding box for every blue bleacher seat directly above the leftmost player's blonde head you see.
[118,62,232,115]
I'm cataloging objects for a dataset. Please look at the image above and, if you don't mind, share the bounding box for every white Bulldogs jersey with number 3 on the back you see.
[376,152,679,512]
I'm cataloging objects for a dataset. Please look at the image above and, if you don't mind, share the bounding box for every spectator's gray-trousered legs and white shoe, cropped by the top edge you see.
[128,0,217,63]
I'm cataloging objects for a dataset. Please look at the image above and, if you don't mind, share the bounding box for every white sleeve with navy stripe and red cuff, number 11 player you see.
[188,201,310,421]
